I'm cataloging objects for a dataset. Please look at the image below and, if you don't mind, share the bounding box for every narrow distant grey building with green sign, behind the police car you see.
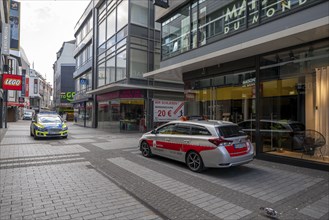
[53,40,75,121]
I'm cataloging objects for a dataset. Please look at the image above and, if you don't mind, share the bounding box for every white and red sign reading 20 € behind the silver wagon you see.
[153,99,184,122]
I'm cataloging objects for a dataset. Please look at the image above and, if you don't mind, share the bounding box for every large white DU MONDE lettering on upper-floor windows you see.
[222,0,315,34]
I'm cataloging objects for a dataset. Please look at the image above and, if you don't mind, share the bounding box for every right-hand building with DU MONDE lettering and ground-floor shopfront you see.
[144,0,329,166]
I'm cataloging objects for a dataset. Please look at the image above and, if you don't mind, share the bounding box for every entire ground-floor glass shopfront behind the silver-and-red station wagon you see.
[184,40,329,163]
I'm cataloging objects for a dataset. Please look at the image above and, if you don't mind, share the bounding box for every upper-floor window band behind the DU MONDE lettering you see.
[161,0,321,60]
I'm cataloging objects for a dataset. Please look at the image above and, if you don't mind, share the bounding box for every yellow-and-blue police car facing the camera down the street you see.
[30,113,68,139]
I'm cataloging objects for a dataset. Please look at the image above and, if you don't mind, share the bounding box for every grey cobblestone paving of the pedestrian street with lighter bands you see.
[0,121,329,220]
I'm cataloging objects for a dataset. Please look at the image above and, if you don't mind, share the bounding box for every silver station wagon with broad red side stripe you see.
[139,120,254,172]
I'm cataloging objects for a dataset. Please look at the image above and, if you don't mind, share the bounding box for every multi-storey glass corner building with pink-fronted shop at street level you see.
[75,0,184,132]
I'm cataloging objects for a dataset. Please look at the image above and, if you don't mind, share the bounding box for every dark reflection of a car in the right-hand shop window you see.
[238,119,305,150]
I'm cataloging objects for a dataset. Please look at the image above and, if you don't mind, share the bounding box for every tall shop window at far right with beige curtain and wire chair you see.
[260,42,329,162]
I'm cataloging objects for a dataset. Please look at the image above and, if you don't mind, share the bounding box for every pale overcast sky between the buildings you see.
[17,0,90,85]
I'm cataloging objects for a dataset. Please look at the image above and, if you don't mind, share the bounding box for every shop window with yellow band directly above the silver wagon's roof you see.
[186,70,256,123]
